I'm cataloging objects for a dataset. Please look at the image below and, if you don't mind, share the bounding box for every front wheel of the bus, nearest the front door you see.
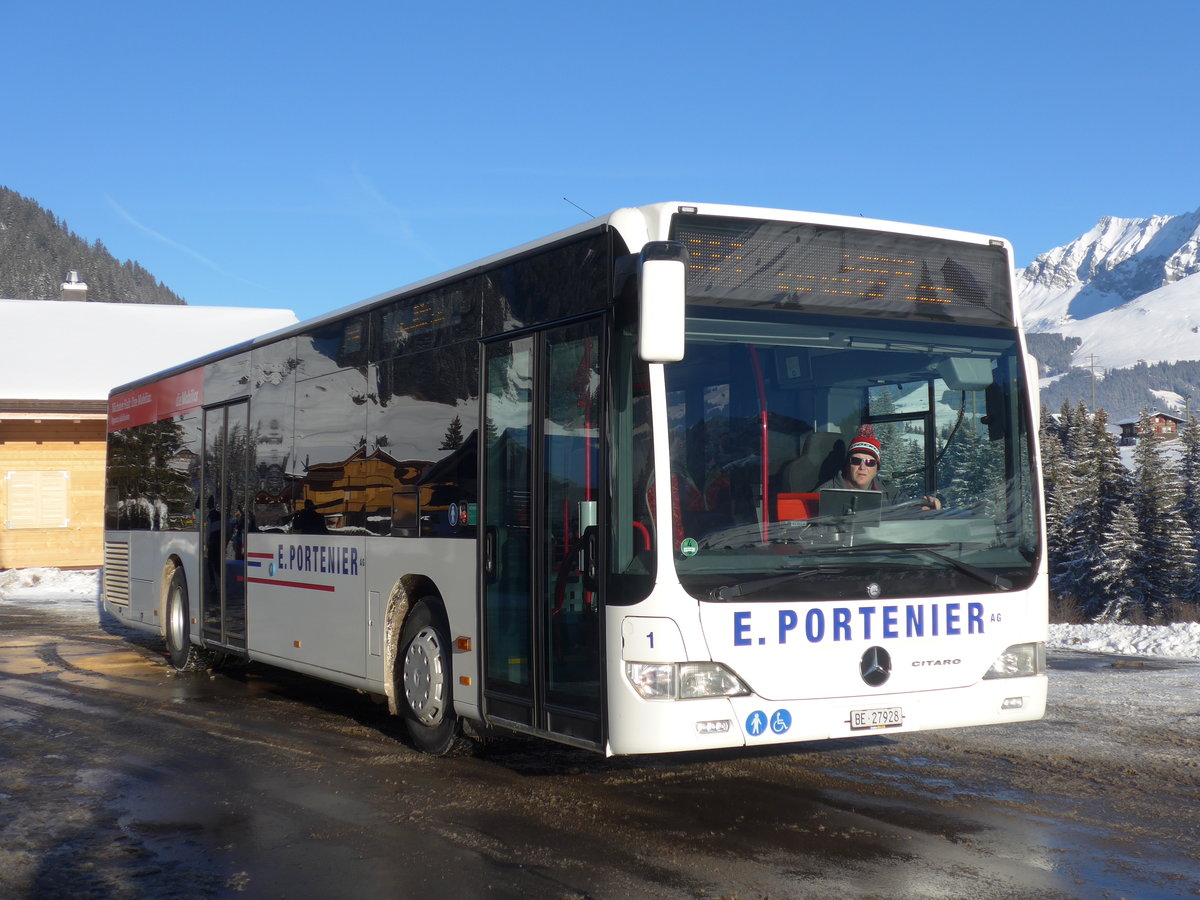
[397,600,473,756]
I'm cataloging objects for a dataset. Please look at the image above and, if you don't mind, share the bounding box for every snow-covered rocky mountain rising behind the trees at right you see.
[1016,210,1200,368]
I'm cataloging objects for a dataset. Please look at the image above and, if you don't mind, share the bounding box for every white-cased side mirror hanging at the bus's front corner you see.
[637,241,688,362]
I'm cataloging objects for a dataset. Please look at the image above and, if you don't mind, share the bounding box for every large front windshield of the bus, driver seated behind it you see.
[665,307,1040,601]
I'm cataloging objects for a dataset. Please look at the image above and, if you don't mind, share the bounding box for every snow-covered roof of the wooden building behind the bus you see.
[0,300,298,400]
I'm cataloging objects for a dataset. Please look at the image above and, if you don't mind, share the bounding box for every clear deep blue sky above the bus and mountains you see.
[7,0,1200,318]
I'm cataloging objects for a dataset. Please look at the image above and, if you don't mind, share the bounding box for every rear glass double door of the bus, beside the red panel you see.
[200,401,250,648]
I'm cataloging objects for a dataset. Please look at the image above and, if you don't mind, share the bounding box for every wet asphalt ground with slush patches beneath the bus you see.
[0,602,1200,900]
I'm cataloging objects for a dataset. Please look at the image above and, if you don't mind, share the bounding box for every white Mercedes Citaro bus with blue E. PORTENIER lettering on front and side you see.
[103,203,1048,755]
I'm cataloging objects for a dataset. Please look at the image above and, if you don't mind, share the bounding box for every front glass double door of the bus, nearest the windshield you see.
[480,319,602,746]
